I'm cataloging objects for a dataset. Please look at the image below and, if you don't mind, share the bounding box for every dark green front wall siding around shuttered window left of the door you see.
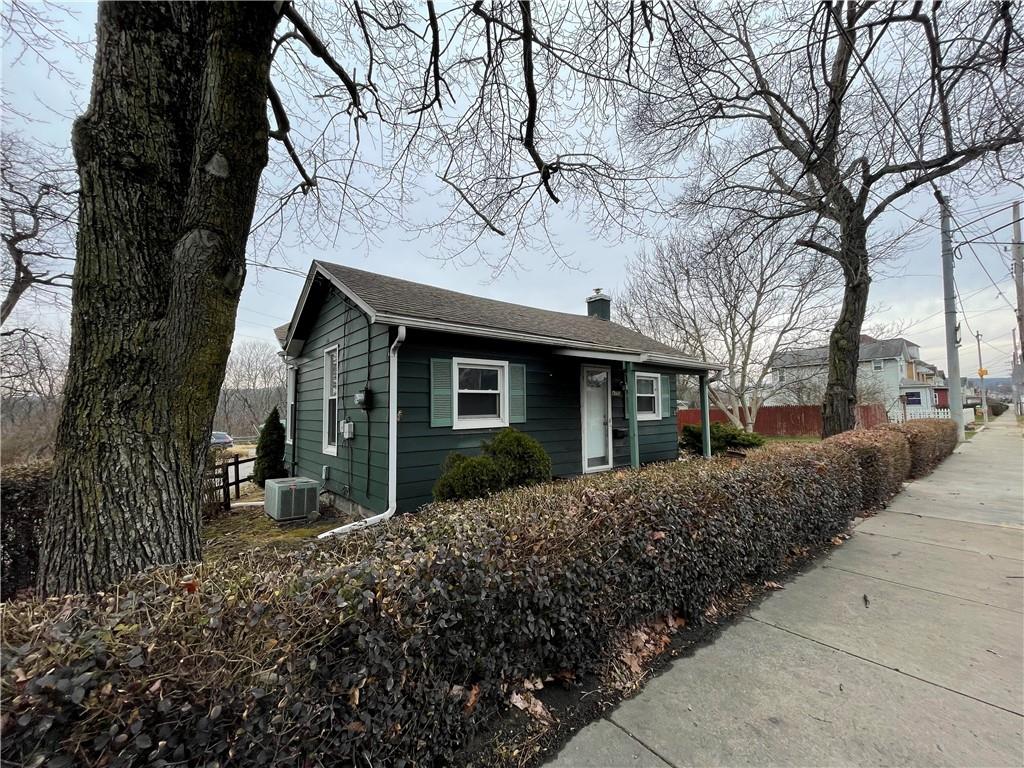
[398,329,582,511]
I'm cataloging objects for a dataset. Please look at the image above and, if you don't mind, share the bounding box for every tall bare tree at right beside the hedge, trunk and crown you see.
[636,2,1024,434]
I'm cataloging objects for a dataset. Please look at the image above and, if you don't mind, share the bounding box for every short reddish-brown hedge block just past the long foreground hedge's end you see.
[824,429,910,512]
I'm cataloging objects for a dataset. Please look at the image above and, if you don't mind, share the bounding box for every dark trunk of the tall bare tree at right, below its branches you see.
[821,222,871,437]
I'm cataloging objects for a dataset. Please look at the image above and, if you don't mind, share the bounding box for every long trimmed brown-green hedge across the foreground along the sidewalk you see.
[2,428,954,766]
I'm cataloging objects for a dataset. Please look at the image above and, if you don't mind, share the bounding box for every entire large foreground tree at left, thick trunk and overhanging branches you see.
[39,1,663,593]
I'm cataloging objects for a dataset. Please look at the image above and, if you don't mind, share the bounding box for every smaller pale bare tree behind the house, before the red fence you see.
[617,221,839,431]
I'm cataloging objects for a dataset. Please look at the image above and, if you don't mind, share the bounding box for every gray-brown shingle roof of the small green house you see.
[314,261,718,369]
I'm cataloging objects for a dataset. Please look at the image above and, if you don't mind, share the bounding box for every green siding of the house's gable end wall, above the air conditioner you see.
[296,290,390,512]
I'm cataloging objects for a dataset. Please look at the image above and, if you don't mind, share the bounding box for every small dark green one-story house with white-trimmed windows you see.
[275,261,720,532]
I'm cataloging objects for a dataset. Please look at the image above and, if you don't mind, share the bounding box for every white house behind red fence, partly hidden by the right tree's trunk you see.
[766,336,949,421]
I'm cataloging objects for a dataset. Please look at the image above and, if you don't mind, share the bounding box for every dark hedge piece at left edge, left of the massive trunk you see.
[0,461,53,600]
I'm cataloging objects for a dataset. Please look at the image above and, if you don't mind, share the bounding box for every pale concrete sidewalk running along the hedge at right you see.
[551,414,1024,768]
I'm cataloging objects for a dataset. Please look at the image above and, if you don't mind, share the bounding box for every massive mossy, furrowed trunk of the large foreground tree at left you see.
[39,2,276,594]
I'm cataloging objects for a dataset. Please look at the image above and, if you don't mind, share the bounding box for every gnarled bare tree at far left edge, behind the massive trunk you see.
[0,133,78,323]
